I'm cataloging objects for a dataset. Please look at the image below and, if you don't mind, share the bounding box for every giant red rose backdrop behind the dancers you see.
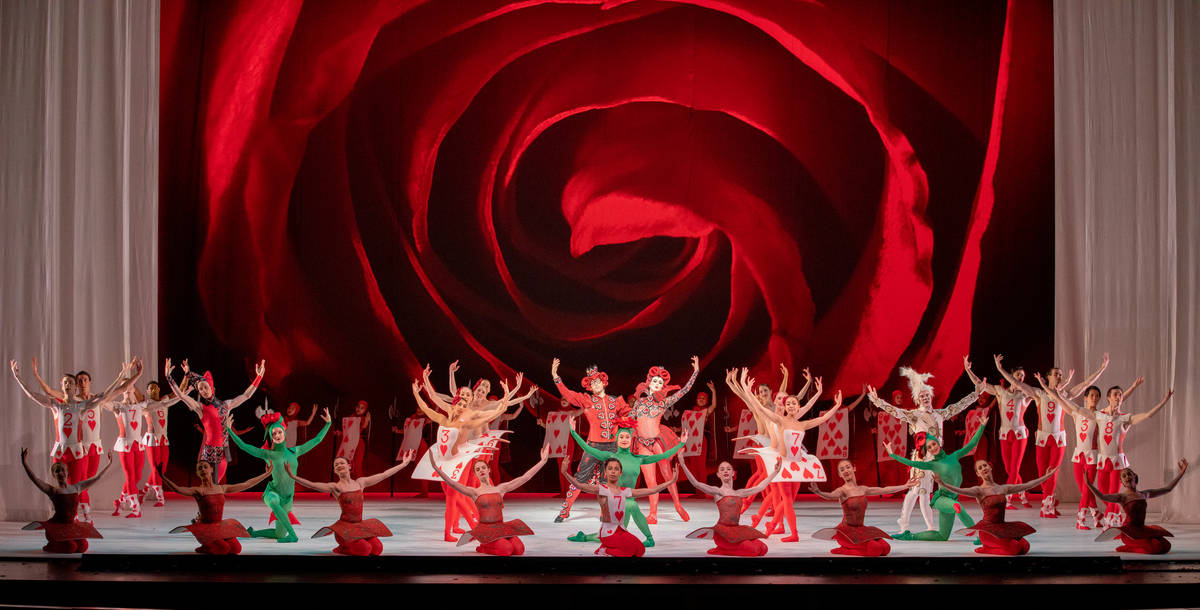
[161,0,1054,485]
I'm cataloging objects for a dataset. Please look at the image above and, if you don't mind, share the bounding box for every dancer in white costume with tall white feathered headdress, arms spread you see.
[866,366,986,533]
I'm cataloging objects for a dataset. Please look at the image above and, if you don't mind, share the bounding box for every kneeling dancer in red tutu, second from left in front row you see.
[158,460,271,555]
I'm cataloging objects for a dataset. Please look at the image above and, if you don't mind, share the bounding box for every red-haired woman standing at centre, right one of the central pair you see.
[630,355,700,525]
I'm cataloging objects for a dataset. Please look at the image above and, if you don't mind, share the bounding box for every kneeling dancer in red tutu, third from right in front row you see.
[809,460,922,557]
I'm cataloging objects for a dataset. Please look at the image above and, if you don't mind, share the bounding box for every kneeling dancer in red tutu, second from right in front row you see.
[935,460,1055,555]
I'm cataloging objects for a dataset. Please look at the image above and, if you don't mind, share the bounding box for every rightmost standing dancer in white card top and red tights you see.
[1038,376,1175,527]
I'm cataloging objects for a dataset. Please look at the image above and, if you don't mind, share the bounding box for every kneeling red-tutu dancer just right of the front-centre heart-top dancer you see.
[679,458,784,557]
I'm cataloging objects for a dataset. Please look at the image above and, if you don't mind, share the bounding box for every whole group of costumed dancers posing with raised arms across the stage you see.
[11,354,1187,556]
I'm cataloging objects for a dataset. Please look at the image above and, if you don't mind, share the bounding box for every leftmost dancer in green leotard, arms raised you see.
[226,408,332,543]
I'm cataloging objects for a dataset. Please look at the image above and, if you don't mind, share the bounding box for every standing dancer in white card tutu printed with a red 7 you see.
[724,369,841,543]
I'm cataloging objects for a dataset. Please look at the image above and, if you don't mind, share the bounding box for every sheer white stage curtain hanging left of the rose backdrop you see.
[0,0,161,520]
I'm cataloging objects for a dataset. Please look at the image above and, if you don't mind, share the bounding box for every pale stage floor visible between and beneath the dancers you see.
[0,494,1200,562]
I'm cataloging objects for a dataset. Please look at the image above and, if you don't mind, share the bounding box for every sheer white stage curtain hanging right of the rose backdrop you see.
[1054,0,1200,522]
